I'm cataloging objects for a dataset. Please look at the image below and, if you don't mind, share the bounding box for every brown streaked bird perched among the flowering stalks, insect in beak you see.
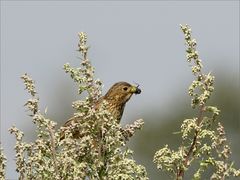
[60,82,141,140]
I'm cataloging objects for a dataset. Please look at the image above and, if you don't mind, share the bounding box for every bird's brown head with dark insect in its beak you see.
[104,82,141,105]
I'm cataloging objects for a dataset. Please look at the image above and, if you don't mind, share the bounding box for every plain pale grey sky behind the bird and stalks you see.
[1,1,239,179]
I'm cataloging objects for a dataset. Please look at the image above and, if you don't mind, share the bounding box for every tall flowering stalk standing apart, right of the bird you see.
[154,25,240,180]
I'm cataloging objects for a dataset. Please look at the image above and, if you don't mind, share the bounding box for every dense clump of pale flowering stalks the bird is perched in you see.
[7,32,148,180]
